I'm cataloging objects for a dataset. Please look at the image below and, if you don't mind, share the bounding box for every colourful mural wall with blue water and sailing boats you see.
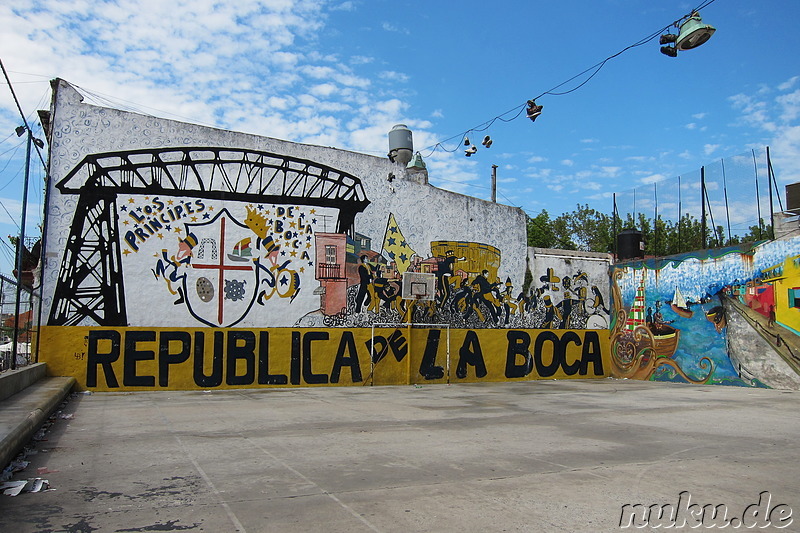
[611,238,800,387]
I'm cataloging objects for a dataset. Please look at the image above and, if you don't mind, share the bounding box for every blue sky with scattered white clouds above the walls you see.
[0,0,800,274]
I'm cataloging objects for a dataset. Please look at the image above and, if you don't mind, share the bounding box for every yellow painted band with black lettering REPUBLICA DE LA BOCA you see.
[42,327,610,391]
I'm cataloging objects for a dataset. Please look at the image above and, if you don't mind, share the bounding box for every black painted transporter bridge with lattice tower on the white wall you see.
[48,147,370,326]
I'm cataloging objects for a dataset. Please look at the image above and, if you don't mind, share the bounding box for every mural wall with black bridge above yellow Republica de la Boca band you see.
[40,80,608,390]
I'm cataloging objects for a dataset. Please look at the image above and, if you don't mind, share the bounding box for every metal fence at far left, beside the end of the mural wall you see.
[0,275,39,371]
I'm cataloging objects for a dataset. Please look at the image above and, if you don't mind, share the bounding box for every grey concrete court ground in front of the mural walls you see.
[0,379,800,533]
